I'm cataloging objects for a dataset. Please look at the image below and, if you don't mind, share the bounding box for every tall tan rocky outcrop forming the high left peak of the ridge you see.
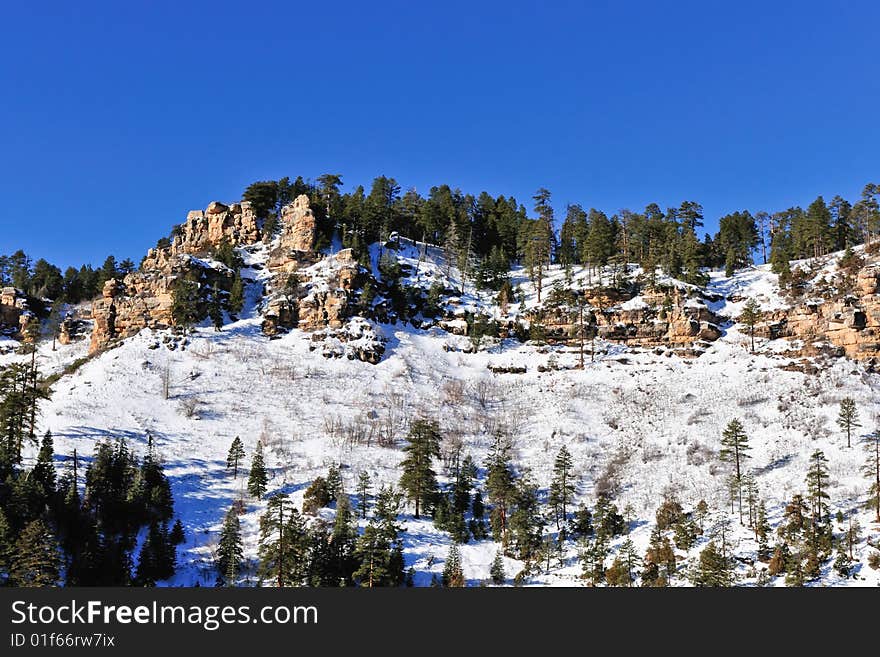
[91,195,359,351]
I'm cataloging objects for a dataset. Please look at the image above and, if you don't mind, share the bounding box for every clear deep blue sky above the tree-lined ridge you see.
[0,0,880,266]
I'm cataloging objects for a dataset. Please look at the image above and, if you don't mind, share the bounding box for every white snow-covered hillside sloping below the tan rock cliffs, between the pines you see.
[0,244,880,586]
